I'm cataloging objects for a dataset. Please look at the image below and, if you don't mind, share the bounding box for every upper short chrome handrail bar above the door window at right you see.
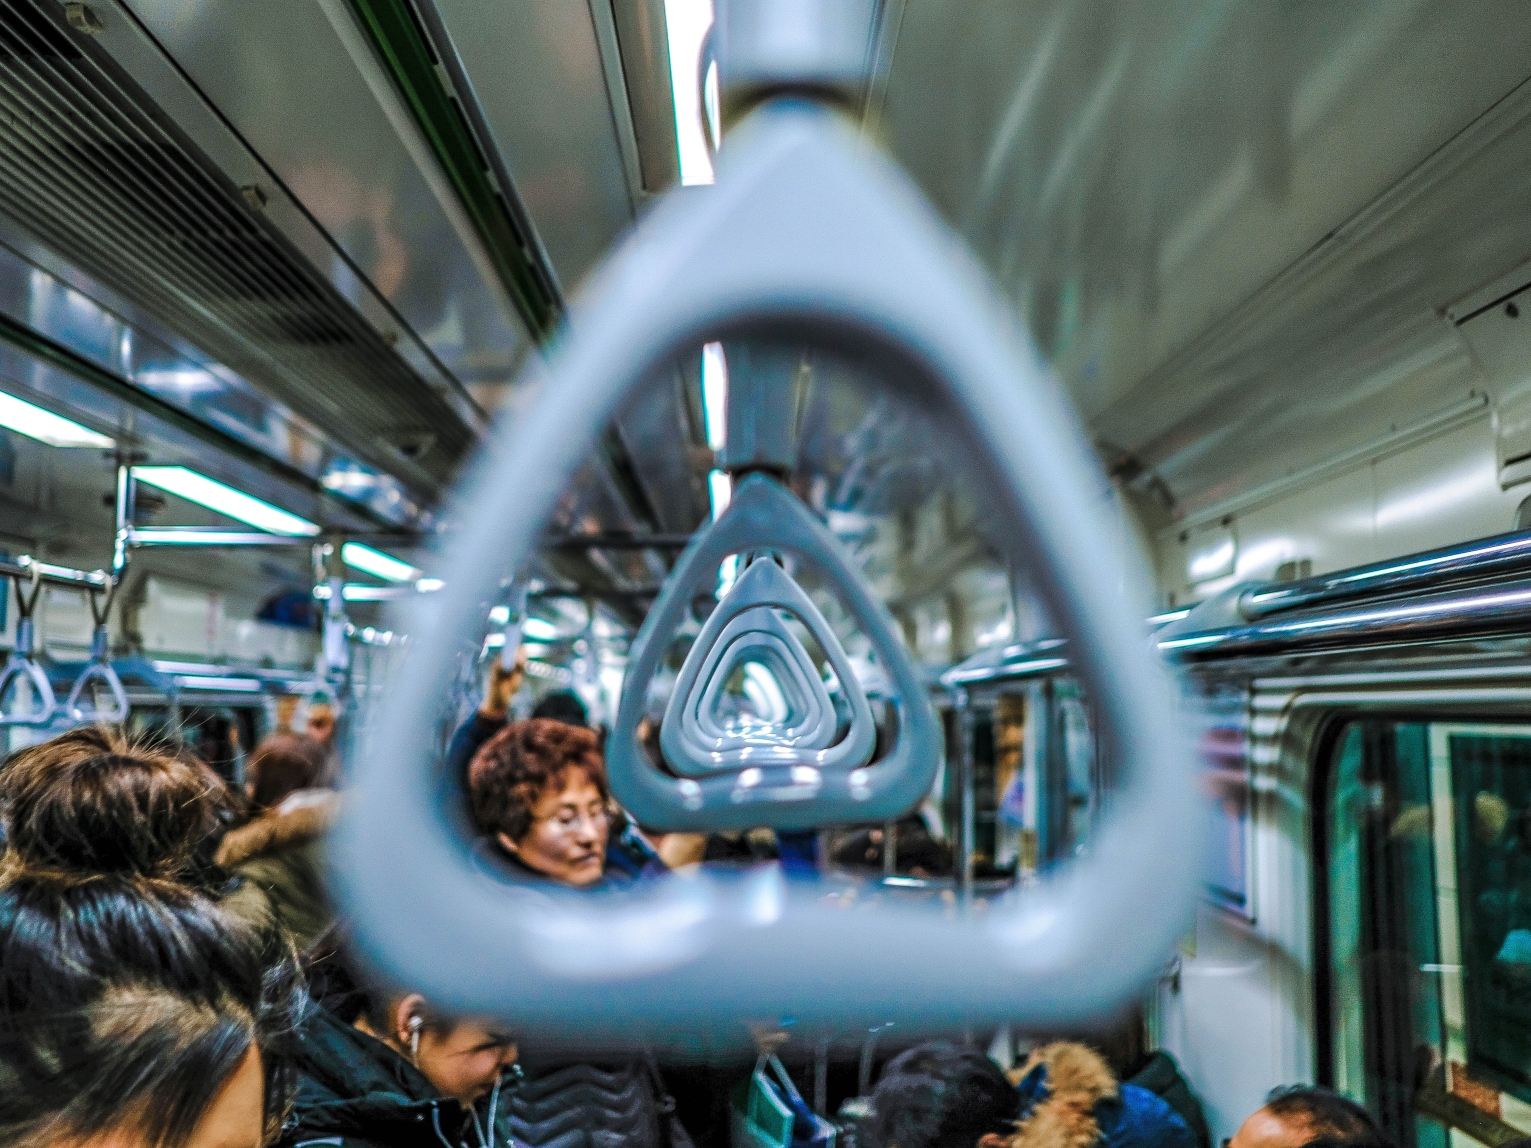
[1239,531,1531,621]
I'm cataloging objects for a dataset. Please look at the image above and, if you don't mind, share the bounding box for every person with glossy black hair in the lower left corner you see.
[0,866,303,1148]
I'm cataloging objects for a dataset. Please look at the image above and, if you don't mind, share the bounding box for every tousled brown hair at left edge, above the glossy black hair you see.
[0,726,243,892]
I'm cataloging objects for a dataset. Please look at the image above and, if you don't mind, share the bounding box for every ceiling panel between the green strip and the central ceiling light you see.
[433,0,641,289]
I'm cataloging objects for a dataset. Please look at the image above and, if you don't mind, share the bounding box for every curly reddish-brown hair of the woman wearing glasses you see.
[468,718,611,842]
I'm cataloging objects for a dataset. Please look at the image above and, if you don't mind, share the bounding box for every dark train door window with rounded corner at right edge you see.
[1320,719,1531,1148]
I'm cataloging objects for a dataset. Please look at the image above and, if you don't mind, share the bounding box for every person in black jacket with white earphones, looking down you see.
[279,941,517,1148]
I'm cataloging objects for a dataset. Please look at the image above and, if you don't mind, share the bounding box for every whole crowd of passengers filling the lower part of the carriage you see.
[0,661,1408,1148]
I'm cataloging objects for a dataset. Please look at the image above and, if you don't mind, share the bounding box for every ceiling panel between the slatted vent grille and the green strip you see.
[114,0,528,407]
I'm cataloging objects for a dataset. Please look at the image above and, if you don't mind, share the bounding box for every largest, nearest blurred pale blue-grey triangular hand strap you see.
[332,104,1205,1039]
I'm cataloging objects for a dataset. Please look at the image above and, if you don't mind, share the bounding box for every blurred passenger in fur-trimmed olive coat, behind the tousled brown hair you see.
[216,733,338,951]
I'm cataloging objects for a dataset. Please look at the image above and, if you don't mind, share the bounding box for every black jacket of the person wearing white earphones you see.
[279,1009,489,1148]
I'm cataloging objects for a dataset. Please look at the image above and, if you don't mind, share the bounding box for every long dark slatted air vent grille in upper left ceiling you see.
[0,0,473,487]
